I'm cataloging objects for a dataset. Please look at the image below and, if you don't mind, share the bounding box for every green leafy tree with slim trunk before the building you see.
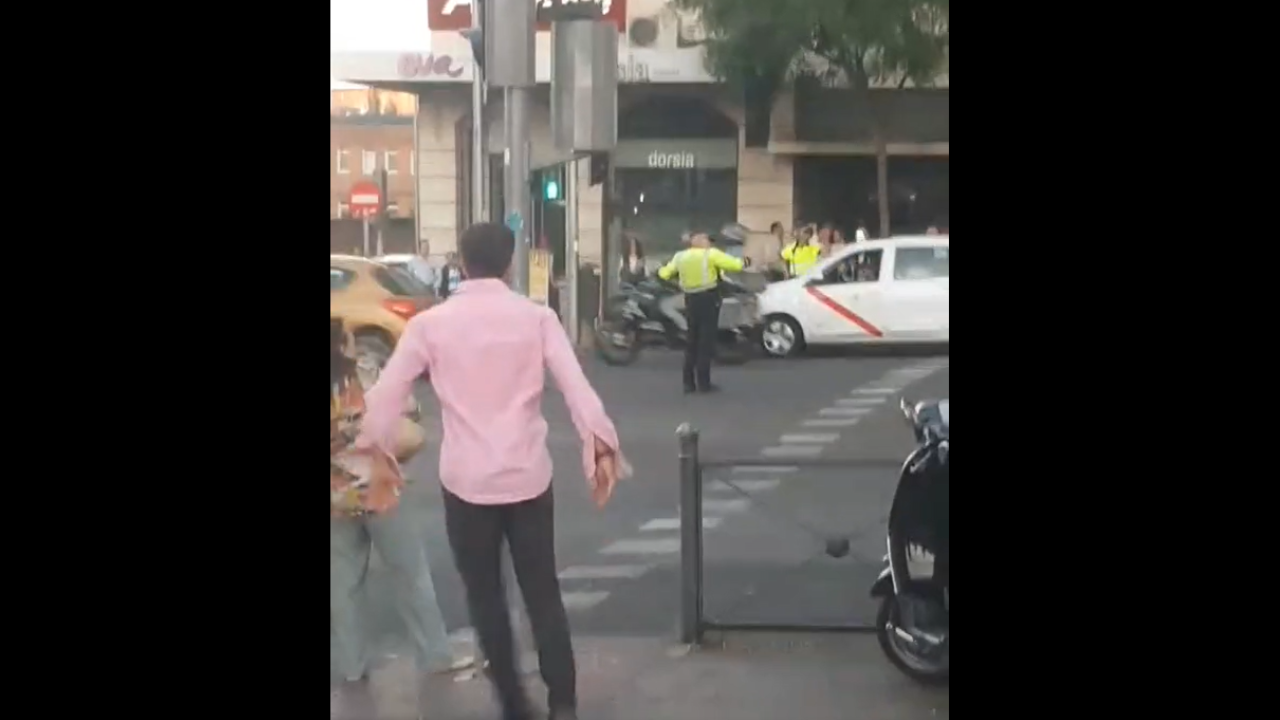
[671,0,950,237]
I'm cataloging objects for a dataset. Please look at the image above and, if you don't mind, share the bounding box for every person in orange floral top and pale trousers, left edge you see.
[329,320,474,682]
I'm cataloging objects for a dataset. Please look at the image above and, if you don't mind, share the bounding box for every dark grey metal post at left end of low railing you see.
[676,423,703,644]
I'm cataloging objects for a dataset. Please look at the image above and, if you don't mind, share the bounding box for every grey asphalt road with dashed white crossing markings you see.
[335,351,948,671]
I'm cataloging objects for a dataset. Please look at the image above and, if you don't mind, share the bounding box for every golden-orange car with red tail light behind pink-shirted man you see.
[329,255,435,373]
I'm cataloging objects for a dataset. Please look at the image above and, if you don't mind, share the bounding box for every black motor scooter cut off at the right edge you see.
[870,400,951,683]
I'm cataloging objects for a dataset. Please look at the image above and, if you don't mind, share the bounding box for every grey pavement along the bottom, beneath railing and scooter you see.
[330,633,950,720]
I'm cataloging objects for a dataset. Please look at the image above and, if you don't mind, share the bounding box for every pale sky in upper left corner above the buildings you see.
[329,0,431,90]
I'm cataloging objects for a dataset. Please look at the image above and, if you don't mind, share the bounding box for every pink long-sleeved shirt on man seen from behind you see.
[357,279,618,505]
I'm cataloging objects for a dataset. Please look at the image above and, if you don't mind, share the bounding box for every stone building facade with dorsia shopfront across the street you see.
[330,0,950,263]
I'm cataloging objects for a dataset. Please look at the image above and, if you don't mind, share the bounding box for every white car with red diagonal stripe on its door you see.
[760,236,951,357]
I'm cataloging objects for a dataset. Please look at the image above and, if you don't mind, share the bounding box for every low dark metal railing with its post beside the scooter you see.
[676,423,902,644]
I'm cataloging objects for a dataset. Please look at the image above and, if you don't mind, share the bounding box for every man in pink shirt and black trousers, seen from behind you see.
[357,223,622,720]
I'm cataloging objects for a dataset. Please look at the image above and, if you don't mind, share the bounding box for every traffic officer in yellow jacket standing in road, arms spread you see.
[658,232,751,393]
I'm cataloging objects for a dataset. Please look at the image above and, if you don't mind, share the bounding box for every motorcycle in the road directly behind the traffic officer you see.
[595,278,759,365]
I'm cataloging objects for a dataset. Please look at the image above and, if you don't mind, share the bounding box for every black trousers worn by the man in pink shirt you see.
[444,488,577,720]
